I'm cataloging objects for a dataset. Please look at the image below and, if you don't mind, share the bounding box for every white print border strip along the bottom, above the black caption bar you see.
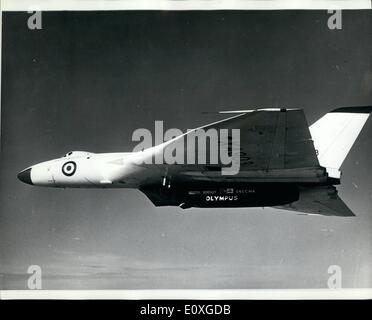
[0,289,372,300]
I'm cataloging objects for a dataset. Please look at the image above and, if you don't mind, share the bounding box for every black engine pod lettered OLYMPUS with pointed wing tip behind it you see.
[140,180,354,217]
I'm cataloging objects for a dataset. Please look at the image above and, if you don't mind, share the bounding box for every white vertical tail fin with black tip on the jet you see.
[310,107,372,170]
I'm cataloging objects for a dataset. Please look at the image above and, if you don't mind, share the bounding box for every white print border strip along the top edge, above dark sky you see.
[1,0,372,11]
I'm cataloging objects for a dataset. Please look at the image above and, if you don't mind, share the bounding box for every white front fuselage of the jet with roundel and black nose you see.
[18,151,160,188]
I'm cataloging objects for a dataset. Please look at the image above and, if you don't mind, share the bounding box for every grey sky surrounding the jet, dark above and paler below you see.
[0,11,372,289]
